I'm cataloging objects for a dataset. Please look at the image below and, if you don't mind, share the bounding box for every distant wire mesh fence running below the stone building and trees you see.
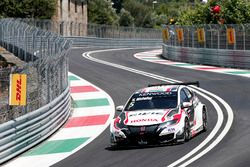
[23,19,162,39]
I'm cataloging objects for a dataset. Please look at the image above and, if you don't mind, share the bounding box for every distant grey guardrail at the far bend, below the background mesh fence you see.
[66,36,162,48]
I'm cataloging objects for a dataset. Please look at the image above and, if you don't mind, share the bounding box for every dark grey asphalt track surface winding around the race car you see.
[54,48,250,167]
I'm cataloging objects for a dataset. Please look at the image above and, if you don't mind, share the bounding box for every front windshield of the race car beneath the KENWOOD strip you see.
[125,92,177,111]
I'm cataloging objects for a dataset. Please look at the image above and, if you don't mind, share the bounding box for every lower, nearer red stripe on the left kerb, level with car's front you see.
[64,115,109,128]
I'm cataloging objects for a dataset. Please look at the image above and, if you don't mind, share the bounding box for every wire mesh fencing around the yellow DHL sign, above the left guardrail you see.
[0,19,71,123]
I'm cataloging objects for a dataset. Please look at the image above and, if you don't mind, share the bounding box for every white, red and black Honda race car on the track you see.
[110,82,207,146]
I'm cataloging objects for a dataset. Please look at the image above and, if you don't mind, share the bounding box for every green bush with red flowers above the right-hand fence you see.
[178,0,250,25]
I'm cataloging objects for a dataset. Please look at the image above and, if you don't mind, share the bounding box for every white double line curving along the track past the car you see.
[83,48,233,167]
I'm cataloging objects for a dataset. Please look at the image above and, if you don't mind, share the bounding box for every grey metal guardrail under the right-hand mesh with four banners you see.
[162,44,250,69]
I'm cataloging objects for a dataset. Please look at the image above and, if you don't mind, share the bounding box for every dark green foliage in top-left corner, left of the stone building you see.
[0,0,57,19]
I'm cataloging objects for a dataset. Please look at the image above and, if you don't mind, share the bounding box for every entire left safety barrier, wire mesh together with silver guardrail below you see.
[0,19,71,163]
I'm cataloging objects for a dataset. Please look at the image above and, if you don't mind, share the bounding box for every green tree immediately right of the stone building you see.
[88,0,119,25]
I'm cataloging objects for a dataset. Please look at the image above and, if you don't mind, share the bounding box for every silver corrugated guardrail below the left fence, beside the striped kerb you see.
[0,88,71,164]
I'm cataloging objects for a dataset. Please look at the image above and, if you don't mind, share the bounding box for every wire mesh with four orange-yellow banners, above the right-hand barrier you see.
[163,24,250,50]
